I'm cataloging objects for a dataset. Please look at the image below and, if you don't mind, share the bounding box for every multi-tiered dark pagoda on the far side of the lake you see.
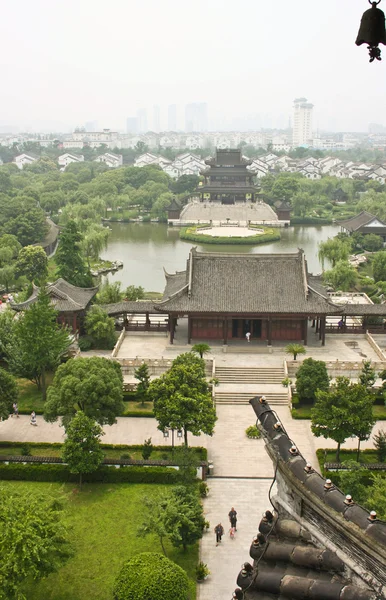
[197,149,258,204]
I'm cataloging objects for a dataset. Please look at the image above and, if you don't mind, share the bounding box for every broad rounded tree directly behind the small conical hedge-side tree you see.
[44,356,124,427]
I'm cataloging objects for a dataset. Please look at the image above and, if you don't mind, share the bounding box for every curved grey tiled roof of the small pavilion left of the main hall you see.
[10,278,99,312]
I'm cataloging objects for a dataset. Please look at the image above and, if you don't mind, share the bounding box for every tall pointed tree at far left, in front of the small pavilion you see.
[8,286,71,400]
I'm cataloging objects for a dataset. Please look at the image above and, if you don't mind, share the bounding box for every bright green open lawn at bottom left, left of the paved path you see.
[2,481,198,600]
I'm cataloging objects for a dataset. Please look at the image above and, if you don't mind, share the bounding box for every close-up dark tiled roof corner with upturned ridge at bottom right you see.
[233,397,386,600]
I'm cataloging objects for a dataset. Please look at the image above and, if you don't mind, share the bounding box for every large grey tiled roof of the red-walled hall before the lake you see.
[158,248,339,314]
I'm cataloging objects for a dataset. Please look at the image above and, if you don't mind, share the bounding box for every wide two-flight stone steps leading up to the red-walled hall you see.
[215,367,288,405]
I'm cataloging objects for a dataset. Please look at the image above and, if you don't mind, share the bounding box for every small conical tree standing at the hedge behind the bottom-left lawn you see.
[62,411,104,487]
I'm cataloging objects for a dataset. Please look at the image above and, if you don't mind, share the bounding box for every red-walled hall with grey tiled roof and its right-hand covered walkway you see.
[154,248,386,346]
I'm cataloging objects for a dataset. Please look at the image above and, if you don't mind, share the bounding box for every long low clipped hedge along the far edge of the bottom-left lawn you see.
[0,463,180,484]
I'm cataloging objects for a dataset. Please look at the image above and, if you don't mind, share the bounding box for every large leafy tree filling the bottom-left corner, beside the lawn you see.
[0,487,72,600]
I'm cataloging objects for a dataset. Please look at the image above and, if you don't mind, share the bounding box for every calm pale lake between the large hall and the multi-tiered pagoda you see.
[101,223,340,292]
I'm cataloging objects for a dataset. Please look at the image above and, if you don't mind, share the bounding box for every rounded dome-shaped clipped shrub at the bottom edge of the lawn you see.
[113,552,189,600]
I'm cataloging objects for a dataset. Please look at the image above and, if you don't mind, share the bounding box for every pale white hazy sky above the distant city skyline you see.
[0,0,386,131]
